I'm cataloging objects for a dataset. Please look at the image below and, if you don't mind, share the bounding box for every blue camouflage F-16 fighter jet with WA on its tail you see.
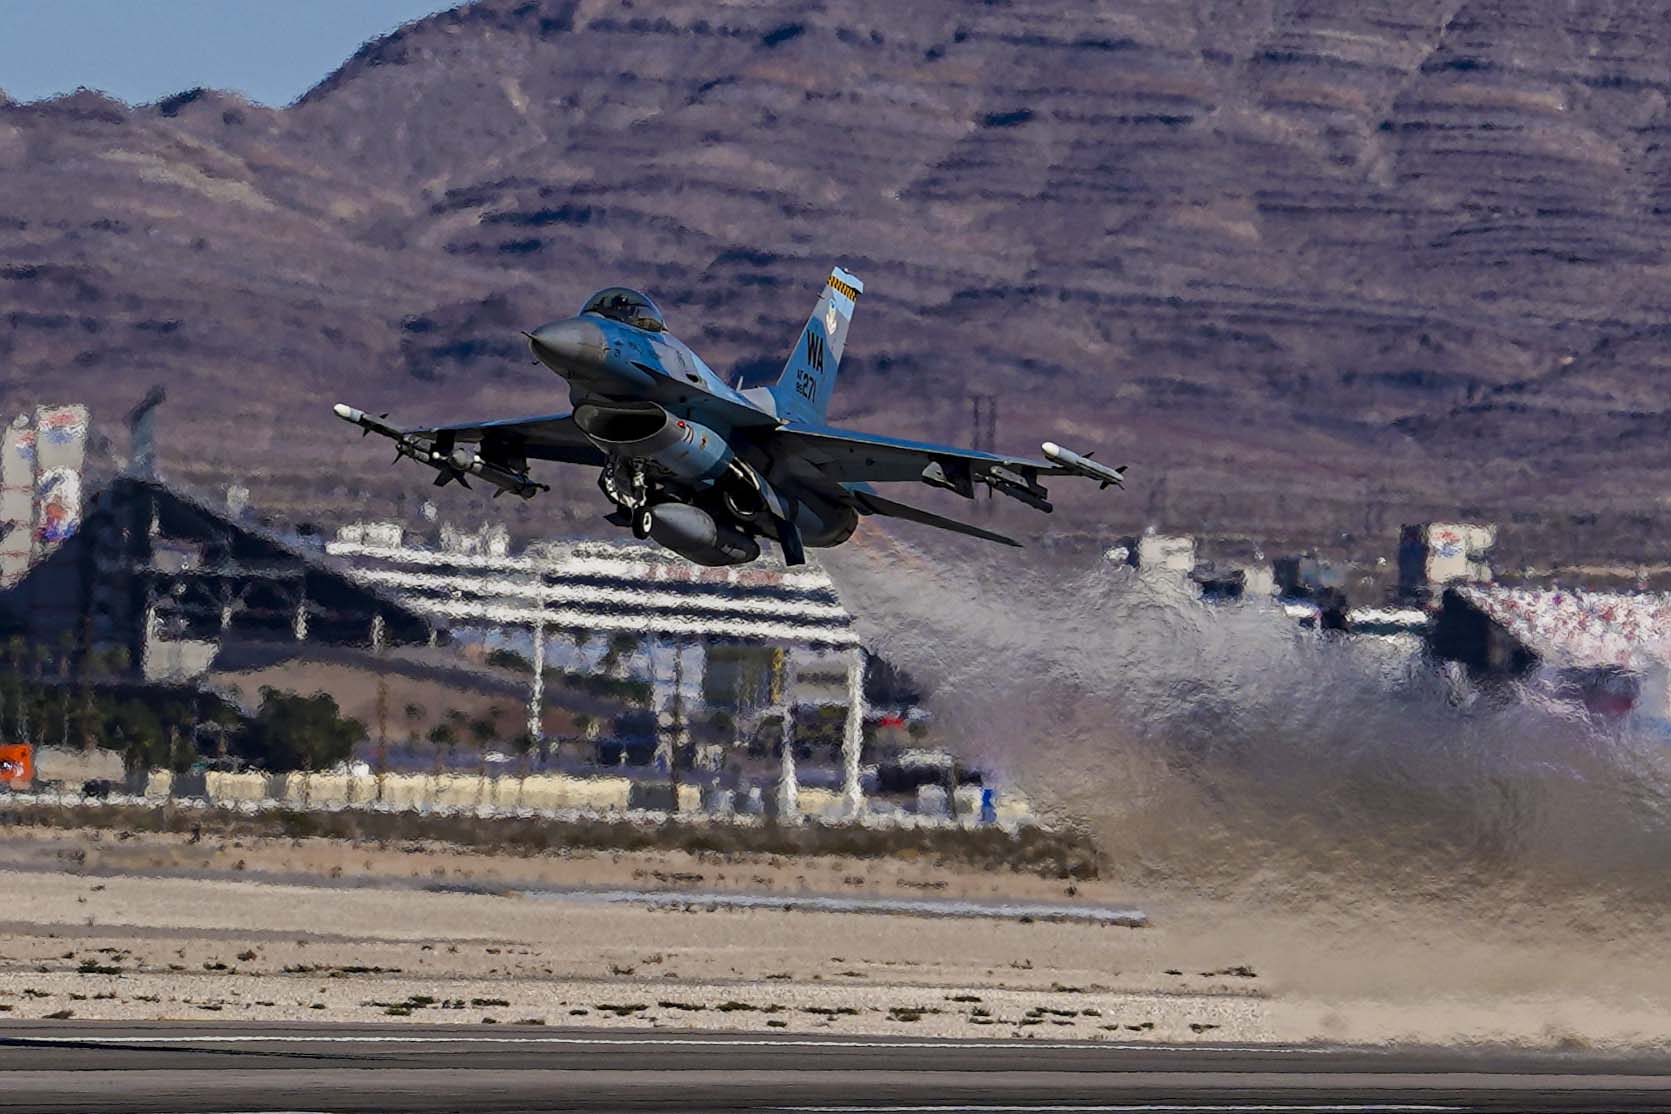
[336,267,1126,565]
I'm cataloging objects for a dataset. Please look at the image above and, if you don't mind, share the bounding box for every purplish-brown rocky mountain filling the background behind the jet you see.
[0,0,1671,561]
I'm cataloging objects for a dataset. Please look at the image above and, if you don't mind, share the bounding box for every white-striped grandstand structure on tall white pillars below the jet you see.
[326,524,864,817]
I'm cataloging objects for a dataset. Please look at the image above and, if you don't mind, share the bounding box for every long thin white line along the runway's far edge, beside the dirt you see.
[0,1032,1330,1062]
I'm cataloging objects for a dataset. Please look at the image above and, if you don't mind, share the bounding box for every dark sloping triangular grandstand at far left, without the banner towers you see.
[0,476,444,724]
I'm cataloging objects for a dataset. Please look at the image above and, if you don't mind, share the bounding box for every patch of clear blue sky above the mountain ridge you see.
[0,0,455,105]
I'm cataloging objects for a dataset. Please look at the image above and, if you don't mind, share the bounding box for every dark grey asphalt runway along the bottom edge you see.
[0,1020,1671,1114]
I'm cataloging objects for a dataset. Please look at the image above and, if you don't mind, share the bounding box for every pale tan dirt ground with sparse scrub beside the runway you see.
[0,828,1671,1049]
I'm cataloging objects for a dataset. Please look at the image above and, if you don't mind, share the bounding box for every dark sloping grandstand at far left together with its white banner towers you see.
[0,392,439,681]
